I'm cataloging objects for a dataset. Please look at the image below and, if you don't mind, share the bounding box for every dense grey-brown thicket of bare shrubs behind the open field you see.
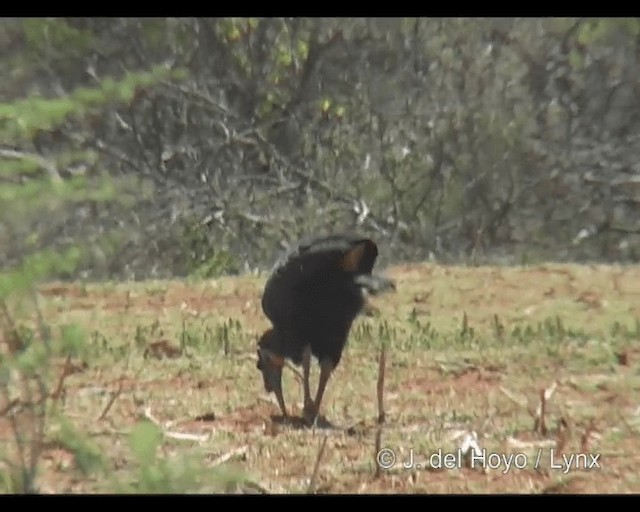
[5,18,640,279]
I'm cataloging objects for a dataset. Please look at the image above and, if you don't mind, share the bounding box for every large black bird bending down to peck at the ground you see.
[257,235,395,424]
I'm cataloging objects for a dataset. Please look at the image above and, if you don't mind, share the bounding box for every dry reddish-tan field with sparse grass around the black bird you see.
[0,264,640,493]
